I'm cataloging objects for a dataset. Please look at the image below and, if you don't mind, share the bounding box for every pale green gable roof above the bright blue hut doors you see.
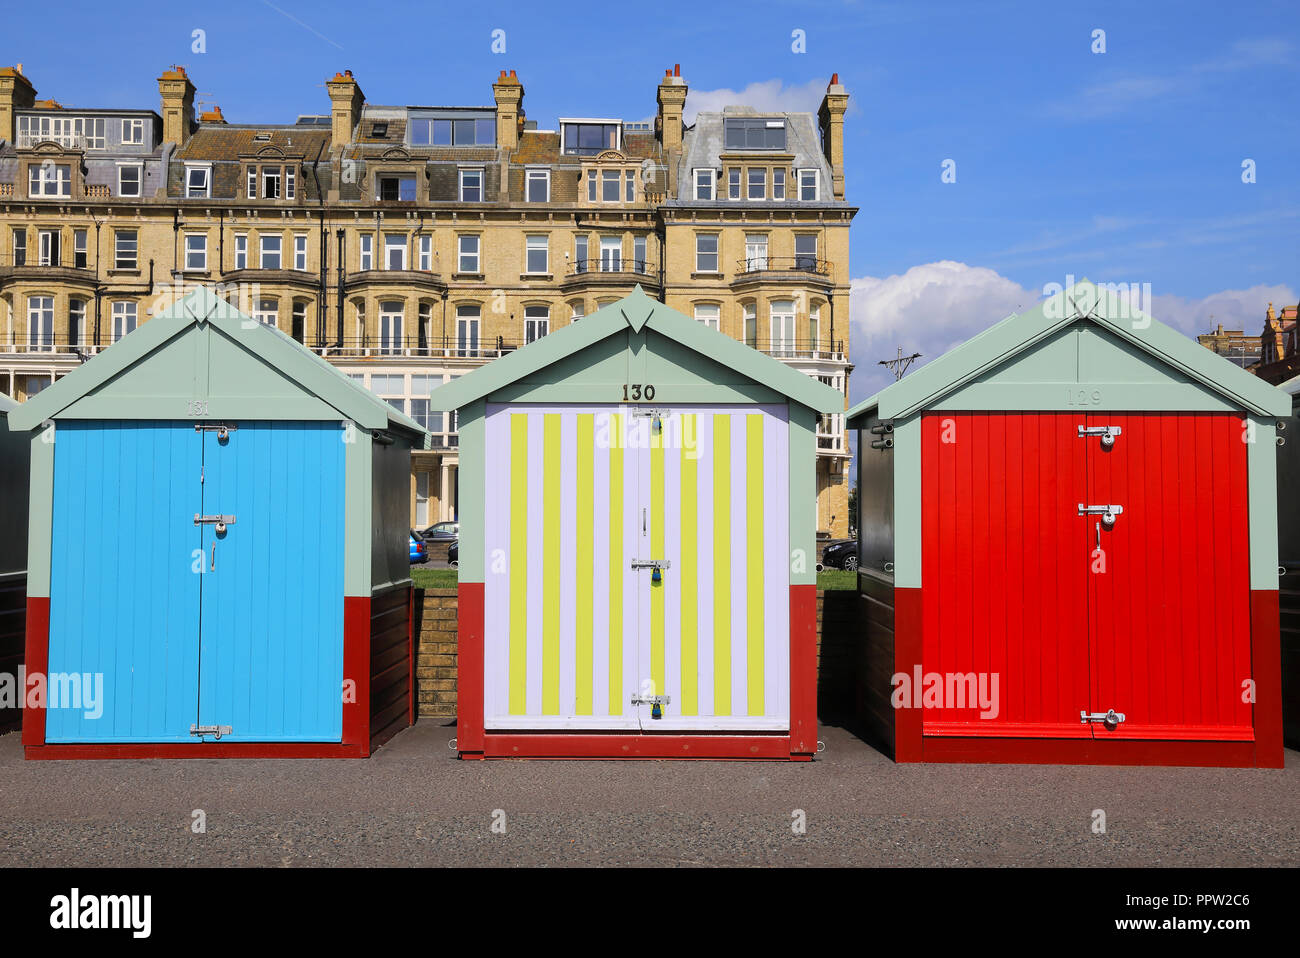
[9,286,426,442]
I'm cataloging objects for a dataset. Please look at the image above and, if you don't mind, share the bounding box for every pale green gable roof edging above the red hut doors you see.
[848,279,1291,428]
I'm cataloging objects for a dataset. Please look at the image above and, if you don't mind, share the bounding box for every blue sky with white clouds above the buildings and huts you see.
[0,0,1300,399]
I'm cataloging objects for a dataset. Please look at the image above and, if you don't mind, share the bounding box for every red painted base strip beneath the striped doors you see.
[473,732,813,762]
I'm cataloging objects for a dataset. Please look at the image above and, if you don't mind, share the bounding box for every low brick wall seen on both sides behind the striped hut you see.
[415,589,859,719]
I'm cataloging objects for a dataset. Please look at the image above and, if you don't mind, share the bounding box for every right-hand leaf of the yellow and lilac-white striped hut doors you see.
[634,406,790,732]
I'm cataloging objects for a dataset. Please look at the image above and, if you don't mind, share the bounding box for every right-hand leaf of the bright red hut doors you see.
[1076,413,1255,741]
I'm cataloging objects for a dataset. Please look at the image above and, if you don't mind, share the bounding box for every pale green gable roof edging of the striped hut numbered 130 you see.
[432,286,844,412]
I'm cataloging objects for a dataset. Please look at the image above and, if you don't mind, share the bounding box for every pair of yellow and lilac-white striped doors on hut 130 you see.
[484,404,789,732]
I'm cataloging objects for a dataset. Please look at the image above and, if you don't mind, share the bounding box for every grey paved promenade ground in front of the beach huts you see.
[0,720,1300,868]
